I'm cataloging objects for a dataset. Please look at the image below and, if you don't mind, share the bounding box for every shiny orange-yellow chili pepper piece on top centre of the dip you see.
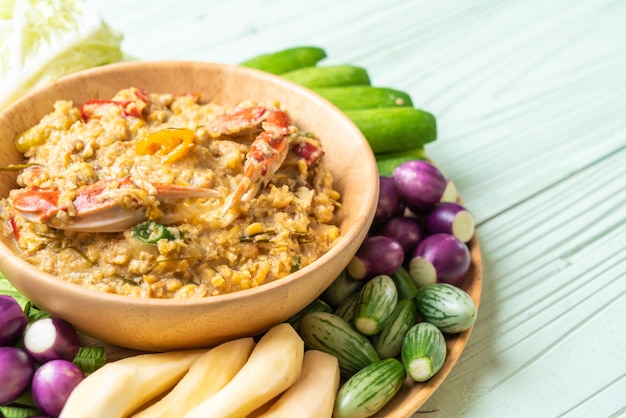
[135,128,194,164]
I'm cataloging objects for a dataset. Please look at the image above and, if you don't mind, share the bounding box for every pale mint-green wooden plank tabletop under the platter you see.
[80,0,626,418]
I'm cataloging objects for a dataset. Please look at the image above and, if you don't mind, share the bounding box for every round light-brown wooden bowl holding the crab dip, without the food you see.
[0,61,379,351]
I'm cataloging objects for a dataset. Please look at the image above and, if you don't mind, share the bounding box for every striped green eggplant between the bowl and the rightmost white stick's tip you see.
[300,312,380,378]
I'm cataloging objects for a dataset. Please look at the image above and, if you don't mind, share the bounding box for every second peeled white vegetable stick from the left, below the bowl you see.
[133,338,254,418]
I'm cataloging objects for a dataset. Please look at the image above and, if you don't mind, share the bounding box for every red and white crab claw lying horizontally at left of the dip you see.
[12,177,220,233]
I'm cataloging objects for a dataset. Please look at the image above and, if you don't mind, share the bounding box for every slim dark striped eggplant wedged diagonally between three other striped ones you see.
[373,299,417,359]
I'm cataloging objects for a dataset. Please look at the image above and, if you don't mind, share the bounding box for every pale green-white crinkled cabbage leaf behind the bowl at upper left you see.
[0,0,124,110]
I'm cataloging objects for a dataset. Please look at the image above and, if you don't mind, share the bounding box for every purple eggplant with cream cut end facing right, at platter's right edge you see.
[424,202,475,243]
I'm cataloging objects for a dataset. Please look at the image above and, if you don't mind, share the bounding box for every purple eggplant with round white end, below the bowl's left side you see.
[23,318,79,363]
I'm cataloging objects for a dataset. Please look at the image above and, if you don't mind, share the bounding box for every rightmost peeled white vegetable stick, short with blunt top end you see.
[259,350,340,418]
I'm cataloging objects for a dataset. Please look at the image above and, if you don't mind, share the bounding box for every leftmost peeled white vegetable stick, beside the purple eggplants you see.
[59,349,207,418]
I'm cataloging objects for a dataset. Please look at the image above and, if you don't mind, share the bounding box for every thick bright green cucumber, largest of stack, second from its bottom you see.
[344,107,437,155]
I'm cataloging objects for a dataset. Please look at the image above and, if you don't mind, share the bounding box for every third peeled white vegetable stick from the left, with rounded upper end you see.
[184,323,304,418]
